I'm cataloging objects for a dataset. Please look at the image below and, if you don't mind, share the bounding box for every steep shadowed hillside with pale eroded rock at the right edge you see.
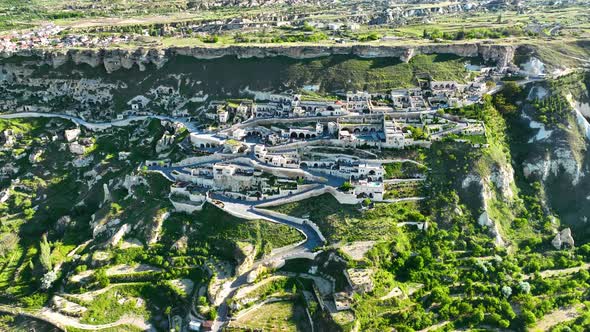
[511,74,590,241]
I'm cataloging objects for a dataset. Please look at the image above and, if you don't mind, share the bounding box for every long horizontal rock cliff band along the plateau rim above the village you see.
[0,43,515,73]
